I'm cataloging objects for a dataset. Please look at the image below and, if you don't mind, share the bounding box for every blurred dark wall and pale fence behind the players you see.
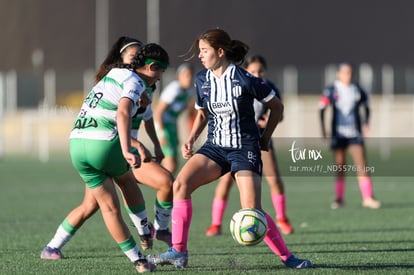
[0,0,414,161]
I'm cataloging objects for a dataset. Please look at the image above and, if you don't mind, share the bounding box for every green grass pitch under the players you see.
[0,156,414,274]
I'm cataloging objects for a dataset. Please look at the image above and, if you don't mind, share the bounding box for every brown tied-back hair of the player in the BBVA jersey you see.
[188,29,249,65]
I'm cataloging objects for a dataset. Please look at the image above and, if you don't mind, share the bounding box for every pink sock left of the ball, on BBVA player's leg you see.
[171,199,193,253]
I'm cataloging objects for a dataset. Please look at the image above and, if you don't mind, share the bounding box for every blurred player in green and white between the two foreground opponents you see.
[154,63,194,174]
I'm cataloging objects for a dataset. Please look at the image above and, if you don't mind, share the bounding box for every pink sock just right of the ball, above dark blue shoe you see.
[264,213,292,261]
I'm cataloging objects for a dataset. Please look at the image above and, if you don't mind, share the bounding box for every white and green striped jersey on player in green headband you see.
[70,68,146,140]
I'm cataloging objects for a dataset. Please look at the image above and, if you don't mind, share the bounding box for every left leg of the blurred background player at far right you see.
[331,148,346,209]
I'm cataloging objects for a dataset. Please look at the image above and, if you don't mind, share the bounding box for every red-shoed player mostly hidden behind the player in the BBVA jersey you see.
[206,55,293,237]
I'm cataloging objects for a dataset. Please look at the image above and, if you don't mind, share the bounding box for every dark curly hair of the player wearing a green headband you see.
[129,43,170,70]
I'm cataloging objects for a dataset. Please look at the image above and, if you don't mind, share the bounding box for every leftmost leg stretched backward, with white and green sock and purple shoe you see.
[40,185,99,260]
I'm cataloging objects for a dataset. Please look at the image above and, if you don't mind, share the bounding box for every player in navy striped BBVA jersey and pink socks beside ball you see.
[148,29,312,268]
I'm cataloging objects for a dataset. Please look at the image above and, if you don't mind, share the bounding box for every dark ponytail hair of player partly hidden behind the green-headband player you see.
[95,36,143,82]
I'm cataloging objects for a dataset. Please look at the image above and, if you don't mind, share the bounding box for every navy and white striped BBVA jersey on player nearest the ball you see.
[195,64,275,149]
